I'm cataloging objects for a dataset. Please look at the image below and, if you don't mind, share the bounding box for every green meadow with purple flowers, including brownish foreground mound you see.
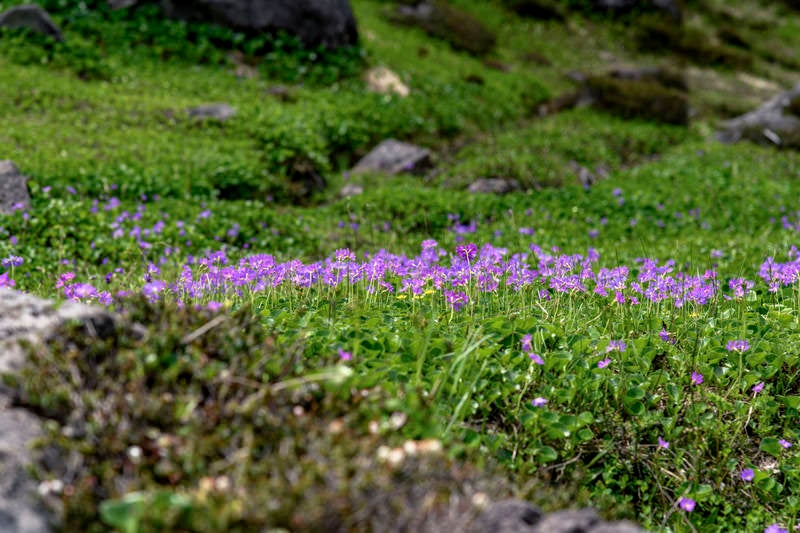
[0,0,800,532]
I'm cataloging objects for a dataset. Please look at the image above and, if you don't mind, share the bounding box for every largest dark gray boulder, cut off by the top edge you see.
[109,0,358,48]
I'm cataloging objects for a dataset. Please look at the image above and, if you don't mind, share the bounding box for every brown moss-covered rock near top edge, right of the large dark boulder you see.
[388,0,497,55]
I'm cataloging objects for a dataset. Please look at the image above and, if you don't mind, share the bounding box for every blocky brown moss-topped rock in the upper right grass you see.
[586,76,689,125]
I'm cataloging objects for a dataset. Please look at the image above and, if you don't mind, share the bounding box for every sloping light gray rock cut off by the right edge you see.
[717,83,800,149]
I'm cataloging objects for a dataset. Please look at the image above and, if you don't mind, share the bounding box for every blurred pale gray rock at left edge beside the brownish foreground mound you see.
[0,288,116,533]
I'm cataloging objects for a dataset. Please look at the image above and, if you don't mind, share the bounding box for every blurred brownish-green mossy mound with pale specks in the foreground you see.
[15,298,528,531]
